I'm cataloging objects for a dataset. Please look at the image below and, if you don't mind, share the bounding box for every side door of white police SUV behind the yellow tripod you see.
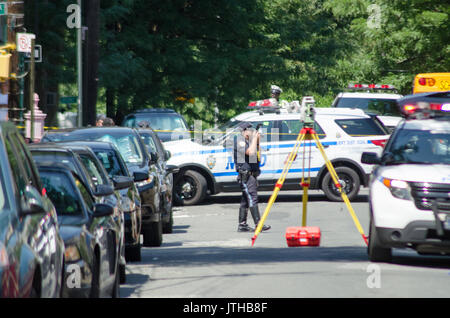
[272,118,327,189]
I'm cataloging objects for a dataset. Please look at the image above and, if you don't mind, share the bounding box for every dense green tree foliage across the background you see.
[26,0,450,124]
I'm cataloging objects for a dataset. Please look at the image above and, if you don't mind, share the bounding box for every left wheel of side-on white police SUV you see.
[175,170,207,205]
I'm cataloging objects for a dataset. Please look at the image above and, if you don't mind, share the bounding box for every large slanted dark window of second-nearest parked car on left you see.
[40,170,82,215]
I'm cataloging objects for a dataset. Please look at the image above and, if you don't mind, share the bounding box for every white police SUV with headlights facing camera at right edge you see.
[362,91,450,262]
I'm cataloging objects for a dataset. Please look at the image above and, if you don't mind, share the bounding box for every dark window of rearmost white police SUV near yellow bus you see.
[336,97,401,116]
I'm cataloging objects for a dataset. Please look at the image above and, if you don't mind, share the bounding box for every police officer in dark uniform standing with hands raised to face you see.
[234,122,270,232]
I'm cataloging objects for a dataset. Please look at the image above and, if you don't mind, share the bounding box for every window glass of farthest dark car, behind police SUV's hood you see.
[123,113,188,132]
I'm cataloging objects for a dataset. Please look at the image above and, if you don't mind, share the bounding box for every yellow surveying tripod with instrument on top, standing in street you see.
[252,96,368,246]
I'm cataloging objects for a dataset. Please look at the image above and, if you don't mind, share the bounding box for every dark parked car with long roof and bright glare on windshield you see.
[41,127,162,246]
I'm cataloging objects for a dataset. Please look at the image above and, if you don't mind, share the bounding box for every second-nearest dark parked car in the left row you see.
[38,163,120,298]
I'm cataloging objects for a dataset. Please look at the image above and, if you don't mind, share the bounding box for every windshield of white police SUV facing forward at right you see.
[386,130,450,164]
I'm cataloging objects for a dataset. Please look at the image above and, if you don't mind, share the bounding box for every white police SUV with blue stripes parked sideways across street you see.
[164,102,389,205]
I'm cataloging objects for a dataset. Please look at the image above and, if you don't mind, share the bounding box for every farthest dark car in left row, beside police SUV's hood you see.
[122,108,191,142]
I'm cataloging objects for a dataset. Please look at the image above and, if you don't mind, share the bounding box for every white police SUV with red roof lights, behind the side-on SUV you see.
[332,84,402,132]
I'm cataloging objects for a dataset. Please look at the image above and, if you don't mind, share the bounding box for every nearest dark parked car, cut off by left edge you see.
[0,122,64,297]
